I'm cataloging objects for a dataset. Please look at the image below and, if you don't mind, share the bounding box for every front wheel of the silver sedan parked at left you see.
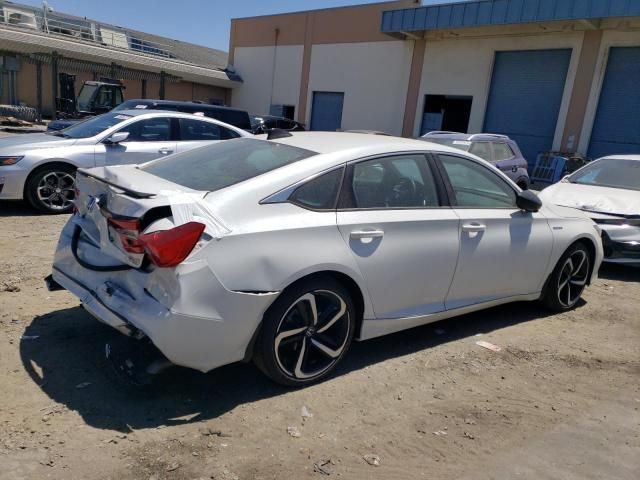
[25,163,76,214]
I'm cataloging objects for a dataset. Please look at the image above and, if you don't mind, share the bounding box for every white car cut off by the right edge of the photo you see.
[540,155,640,265]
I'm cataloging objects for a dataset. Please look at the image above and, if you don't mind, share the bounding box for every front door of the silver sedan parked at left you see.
[95,117,176,166]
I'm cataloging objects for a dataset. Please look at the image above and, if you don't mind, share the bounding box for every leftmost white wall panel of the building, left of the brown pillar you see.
[232,45,304,113]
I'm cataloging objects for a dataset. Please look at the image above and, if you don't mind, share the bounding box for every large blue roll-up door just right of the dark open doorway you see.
[484,49,571,167]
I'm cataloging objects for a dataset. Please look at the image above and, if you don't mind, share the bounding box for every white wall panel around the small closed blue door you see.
[306,41,413,135]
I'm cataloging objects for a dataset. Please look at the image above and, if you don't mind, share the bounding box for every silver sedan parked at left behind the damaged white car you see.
[0,109,250,213]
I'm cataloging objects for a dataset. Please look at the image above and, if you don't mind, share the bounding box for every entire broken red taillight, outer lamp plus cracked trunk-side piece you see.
[108,217,205,267]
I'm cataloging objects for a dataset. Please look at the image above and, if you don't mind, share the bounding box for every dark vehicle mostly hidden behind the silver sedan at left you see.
[47,99,252,132]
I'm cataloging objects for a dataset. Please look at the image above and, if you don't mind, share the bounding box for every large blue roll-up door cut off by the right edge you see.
[588,47,640,158]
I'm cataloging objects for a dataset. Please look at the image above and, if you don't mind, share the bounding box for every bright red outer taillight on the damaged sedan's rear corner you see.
[137,222,205,267]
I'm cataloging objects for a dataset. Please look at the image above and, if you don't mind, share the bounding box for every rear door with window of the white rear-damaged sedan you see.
[337,153,459,319]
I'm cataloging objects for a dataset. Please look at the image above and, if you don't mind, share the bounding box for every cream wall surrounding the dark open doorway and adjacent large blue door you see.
[413,32,583,149]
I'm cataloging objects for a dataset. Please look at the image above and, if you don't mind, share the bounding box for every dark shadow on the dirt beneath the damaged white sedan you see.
[20,303,564,432]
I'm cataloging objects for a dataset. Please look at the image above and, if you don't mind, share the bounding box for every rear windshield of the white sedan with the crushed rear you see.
[140,138,317,192]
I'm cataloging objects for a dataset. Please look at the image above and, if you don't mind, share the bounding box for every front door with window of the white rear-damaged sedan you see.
[439,154,552,309]
